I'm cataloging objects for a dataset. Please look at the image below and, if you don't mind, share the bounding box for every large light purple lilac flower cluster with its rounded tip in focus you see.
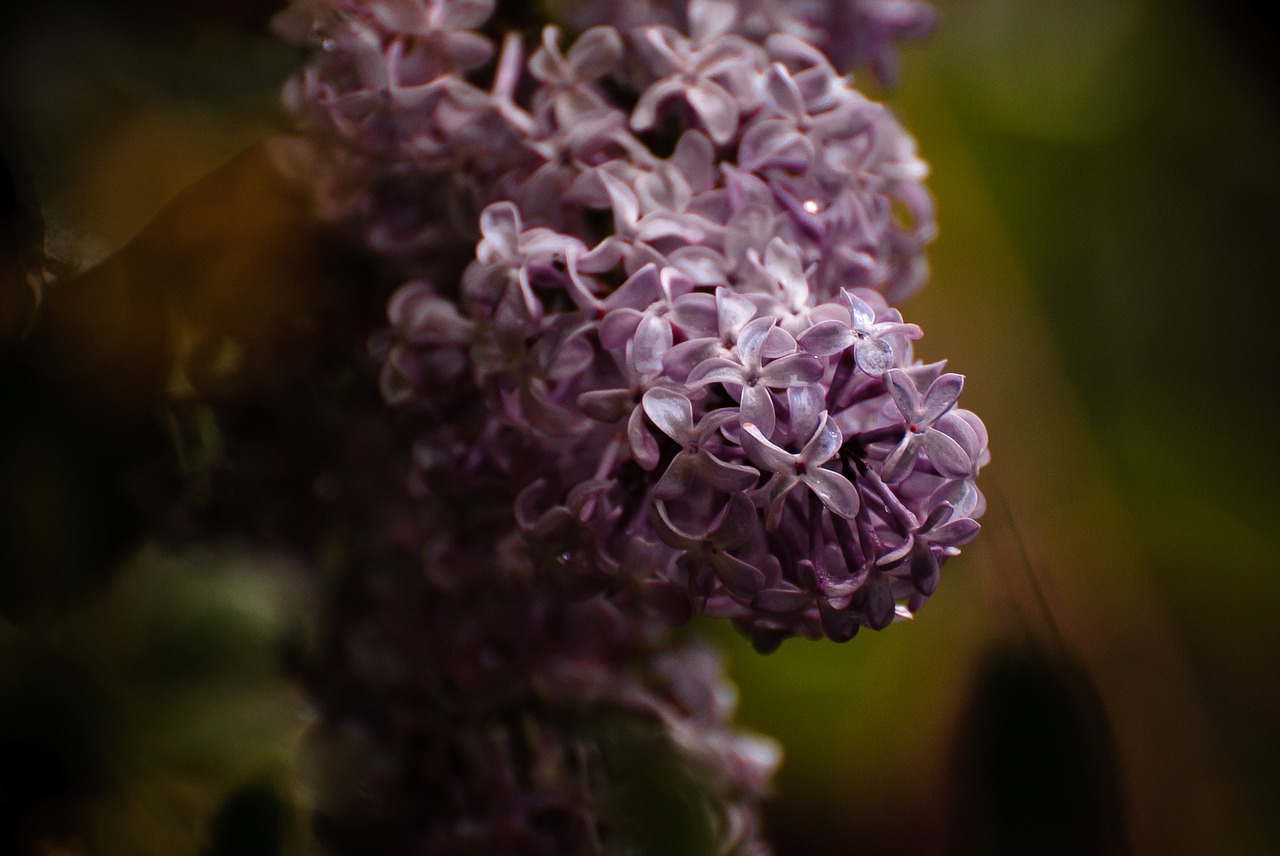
[280,0,987,637]
